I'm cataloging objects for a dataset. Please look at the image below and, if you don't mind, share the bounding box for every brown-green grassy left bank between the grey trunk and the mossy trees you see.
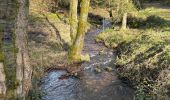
[28,0,70,100]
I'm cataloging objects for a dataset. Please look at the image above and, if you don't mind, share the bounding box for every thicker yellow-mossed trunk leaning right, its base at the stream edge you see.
[69,0,90,62]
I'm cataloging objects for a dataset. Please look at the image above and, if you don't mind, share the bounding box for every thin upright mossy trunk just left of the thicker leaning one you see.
[70,0,78,44]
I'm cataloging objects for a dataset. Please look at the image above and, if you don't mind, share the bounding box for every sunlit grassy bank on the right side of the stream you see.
[96,7,170,100]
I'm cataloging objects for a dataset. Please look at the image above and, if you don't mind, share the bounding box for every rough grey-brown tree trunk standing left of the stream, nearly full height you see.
[15,0,32,97]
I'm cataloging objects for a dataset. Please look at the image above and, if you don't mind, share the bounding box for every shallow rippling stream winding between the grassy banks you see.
[40,21,134,100]
